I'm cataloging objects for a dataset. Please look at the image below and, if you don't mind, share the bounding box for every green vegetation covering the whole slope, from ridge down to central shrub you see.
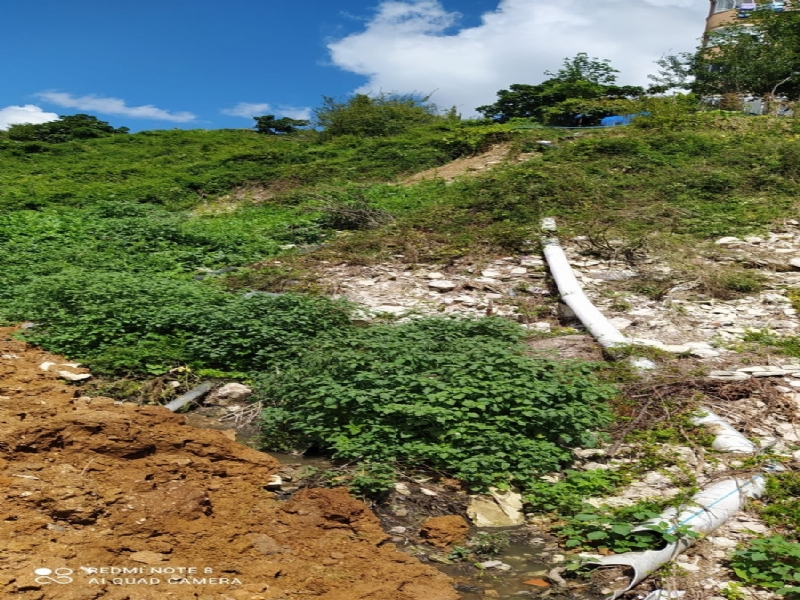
[0,79,800,506]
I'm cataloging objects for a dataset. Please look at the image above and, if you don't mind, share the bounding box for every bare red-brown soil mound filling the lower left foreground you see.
[0,329,459,600]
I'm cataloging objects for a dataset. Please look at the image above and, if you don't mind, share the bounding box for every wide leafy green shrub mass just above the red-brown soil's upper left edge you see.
[7,270,349,373]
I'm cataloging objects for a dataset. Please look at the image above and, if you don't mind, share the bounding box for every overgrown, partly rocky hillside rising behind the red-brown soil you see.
[0,110,800,598]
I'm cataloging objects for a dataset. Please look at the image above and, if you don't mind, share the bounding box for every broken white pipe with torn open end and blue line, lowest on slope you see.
[588,475,765,600]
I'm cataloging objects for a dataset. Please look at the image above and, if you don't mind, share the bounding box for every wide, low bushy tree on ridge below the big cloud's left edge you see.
[314,93,443,137]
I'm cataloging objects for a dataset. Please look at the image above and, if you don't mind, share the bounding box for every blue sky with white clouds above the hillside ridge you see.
[0,0,707,131]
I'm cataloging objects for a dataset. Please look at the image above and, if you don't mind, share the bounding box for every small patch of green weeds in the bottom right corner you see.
[730,535,800,599]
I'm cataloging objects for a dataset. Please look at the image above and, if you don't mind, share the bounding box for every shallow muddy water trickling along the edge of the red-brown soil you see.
[186,408,602,600]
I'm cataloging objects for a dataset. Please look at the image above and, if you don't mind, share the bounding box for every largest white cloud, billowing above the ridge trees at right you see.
[328,0,708,115]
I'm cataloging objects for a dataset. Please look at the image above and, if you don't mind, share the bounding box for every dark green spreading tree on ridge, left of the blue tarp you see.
[476,52,644,125]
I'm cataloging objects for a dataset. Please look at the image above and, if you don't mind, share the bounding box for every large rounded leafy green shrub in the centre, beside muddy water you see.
[258,319,614,488]
